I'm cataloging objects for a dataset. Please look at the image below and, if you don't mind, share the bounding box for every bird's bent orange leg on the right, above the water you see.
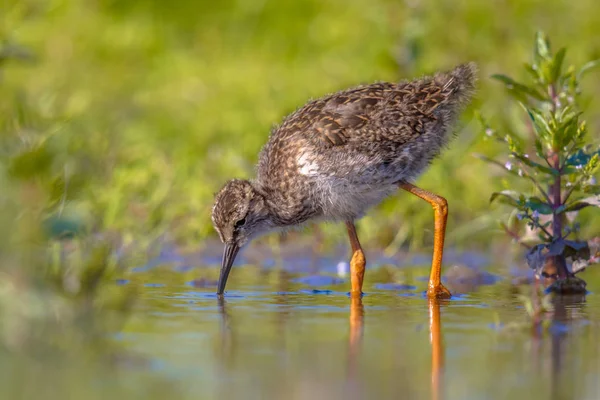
[399,182,451,298]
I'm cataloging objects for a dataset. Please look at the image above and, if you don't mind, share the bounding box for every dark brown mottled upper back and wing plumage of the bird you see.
[277,64,476,146]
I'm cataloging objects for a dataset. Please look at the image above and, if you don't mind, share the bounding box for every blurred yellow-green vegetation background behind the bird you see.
[0,0,600,250]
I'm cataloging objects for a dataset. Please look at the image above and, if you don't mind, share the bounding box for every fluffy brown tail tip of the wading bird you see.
[433,62,477,108]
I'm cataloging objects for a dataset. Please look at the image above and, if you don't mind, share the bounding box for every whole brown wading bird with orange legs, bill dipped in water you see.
[212,64,476,297]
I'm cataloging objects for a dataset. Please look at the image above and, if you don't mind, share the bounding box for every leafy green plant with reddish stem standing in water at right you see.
[481,32,600,277]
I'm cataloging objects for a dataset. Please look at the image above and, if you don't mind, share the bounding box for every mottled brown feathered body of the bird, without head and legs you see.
[257,64,476,220]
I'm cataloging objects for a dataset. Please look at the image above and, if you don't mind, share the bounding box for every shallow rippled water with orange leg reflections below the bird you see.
[4,247,600,399]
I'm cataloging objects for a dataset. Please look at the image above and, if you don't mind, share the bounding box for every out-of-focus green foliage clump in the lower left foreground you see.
[0,241,135,355]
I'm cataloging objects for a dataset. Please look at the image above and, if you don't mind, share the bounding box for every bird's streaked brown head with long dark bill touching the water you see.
[212,179,271,294]
